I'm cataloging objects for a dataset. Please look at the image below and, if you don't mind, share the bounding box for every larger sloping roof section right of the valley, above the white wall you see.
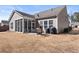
[35,6,66,19]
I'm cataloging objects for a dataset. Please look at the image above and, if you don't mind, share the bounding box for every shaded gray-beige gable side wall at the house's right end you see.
[58,7,69,33]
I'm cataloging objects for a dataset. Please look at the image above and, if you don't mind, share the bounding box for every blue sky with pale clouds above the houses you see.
[0,5,79,21]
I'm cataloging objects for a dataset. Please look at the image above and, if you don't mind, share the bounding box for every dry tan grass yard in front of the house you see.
[0,29,79,53]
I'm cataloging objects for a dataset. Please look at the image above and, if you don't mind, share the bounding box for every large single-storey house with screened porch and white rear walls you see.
[9,6,69,33]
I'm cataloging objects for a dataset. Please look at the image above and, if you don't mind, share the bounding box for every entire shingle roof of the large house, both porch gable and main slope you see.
[9,6,66,21]
